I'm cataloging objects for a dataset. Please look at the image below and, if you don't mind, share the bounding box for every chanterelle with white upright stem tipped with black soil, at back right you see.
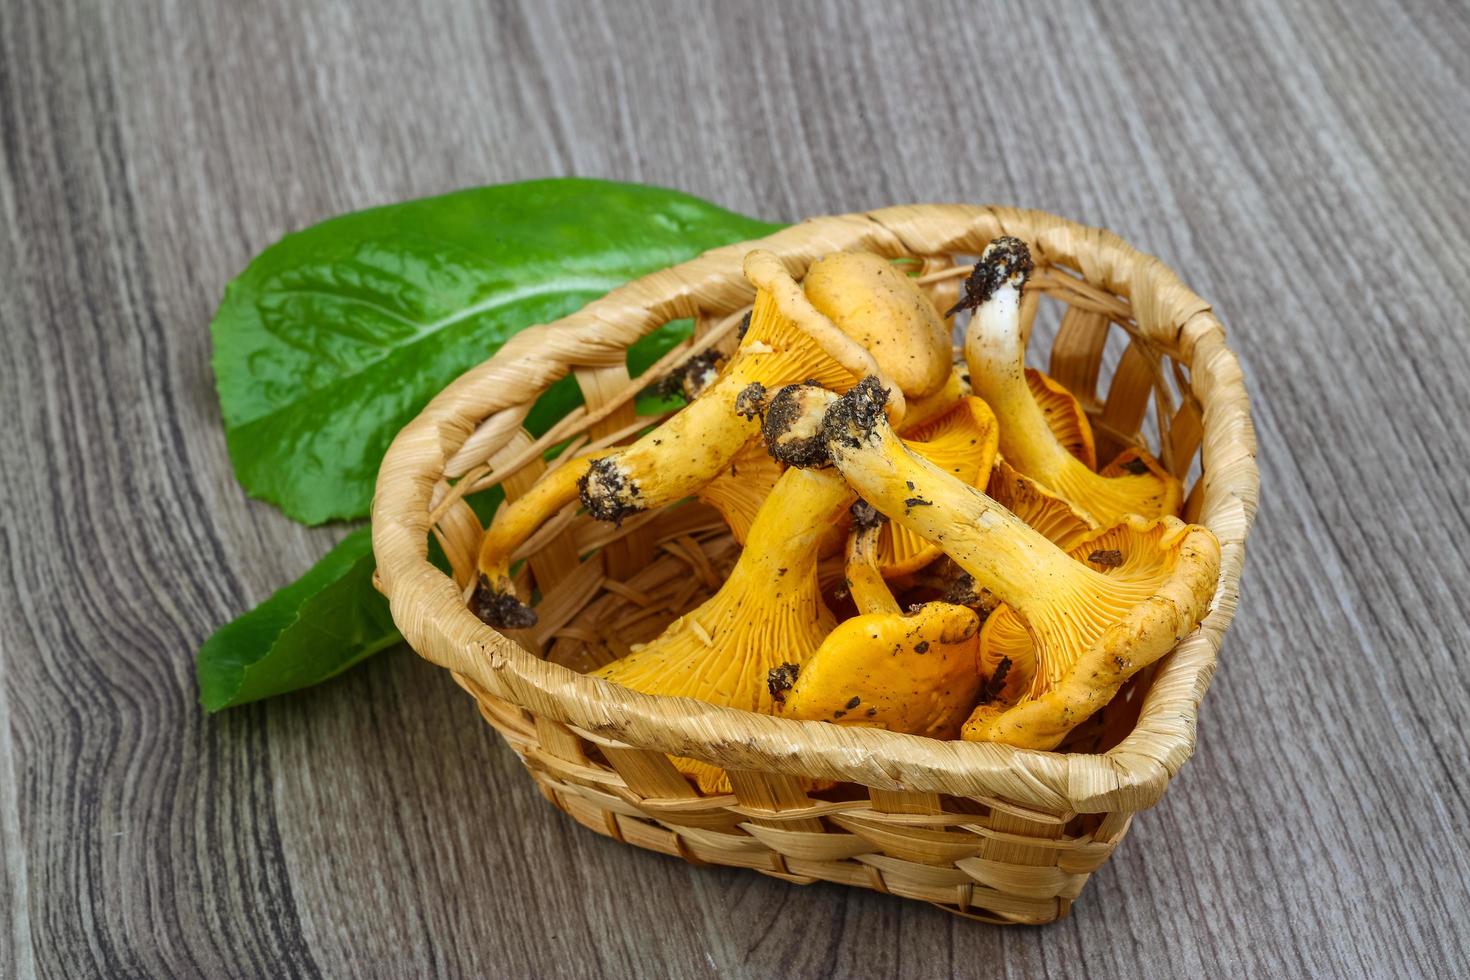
[956,238,1182,527]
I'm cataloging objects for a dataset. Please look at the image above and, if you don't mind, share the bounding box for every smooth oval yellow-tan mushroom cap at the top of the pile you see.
[801,251,950,397]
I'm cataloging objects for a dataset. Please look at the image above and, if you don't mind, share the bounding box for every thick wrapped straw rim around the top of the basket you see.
[372,204,1258,813]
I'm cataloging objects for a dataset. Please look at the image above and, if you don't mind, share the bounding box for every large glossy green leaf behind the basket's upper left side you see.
[212,178,776,523]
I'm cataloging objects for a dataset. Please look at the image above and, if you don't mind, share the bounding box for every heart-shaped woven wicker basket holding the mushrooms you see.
[373,206,1257,923]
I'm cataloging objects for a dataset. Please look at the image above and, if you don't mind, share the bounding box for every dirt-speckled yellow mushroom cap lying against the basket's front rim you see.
[781,602,980,739]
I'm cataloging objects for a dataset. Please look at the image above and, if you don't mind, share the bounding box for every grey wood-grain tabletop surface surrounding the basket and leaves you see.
[0,0,1470,977]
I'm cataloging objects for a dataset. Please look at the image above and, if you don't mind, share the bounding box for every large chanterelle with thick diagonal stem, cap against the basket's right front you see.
[769,379,1220,748]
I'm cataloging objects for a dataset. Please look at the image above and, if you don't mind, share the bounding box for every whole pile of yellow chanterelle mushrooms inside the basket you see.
[470,238,1220,792]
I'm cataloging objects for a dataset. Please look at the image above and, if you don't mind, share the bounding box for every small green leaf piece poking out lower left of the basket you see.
[197,527,403,711]
